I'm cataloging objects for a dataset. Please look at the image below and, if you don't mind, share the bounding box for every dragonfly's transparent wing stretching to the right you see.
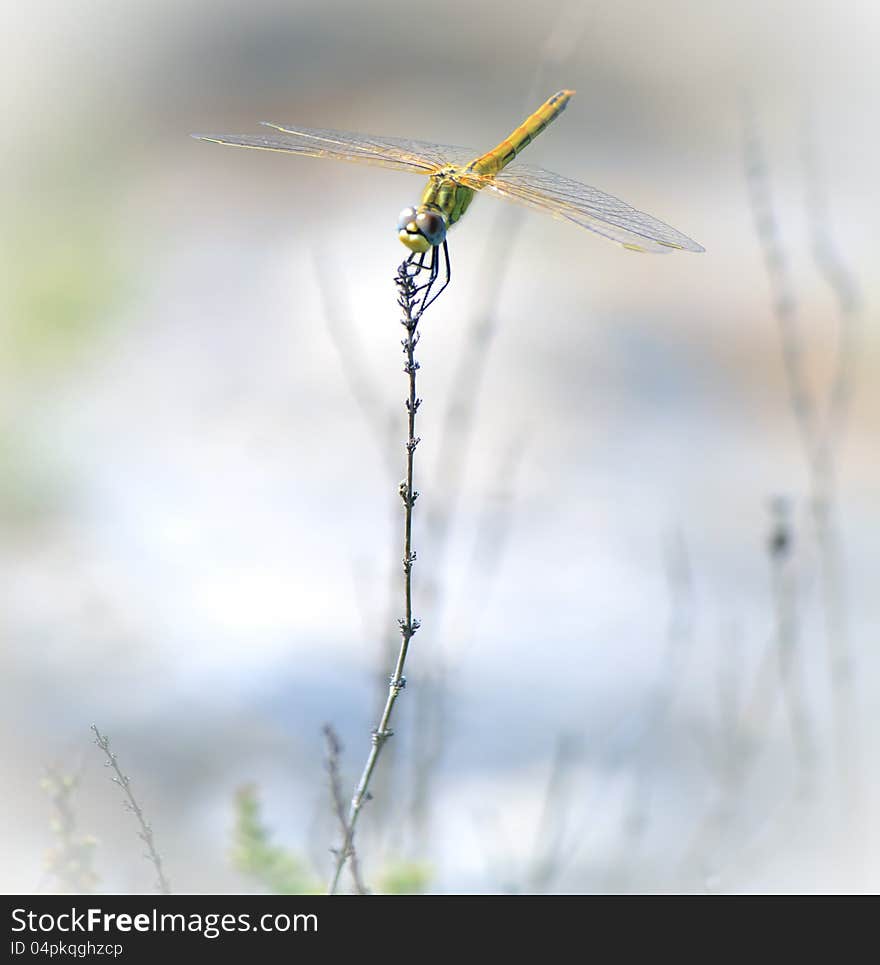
[463,162,705,253]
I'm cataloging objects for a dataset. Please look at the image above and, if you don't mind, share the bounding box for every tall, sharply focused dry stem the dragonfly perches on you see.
[328,262,421,895]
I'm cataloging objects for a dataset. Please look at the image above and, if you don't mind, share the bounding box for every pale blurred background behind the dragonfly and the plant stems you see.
[0,0,880,892]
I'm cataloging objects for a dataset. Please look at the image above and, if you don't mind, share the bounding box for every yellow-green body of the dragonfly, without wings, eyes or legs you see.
[400,90,574,252]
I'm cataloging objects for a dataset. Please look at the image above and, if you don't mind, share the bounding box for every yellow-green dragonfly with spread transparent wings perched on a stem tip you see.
[193,90,705,311]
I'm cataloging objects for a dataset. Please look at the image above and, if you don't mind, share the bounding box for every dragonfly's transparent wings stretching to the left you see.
[193,121,478,174]
